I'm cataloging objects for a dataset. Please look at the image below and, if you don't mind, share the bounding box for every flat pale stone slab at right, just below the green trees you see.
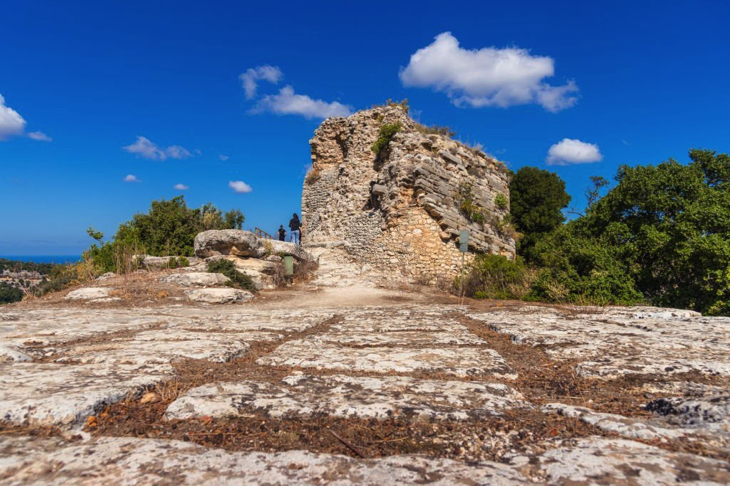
[468,306,730,378]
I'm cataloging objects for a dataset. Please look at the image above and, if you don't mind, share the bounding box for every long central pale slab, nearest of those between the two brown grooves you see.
[165,375,531,420]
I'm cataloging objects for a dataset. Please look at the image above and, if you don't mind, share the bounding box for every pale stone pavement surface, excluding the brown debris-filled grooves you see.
[0,276,730,485]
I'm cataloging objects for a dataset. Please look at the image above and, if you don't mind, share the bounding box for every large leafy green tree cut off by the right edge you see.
[581,150,730,314]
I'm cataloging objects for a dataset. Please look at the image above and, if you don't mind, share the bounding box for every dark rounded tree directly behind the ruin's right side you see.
[509,167,570,261]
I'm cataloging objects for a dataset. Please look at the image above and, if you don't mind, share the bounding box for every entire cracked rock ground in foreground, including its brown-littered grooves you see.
[0,278,730,485]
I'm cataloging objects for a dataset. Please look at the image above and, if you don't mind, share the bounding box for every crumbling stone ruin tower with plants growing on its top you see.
[302,105,515,284]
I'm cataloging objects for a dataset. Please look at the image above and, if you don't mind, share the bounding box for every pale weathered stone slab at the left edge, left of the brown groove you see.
[0,363,173,426]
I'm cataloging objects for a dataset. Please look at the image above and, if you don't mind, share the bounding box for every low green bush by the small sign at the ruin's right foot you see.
[464,255,534,299]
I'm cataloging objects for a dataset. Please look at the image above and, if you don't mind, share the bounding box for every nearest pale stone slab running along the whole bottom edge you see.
[5,437,730,486]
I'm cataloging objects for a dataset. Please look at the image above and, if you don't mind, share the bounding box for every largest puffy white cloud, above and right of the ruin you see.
[399,32,578,112]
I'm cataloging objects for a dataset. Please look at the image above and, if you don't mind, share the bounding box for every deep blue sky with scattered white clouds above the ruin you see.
[0,0,730,254]
